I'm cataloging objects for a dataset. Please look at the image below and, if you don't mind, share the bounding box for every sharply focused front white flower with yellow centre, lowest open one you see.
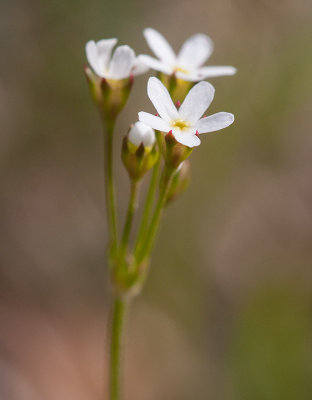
[139,77,234,147]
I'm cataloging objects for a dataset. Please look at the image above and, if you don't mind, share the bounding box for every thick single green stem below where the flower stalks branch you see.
[110,297,126,400]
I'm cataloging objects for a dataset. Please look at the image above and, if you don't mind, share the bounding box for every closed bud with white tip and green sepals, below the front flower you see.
[121,121,159,181]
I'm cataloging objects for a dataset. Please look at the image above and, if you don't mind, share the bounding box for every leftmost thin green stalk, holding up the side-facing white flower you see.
[104,122,118,255]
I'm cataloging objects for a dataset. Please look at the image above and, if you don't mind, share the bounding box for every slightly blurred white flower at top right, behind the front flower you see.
[138,28,236,82]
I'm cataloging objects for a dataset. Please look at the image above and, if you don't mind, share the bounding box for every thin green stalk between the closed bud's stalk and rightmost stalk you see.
[135,157,161,252]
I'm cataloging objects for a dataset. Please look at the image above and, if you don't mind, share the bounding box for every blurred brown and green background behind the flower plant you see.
[0,0,312,400]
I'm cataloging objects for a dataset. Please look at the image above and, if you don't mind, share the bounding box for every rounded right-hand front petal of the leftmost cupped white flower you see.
[109,46,135,80]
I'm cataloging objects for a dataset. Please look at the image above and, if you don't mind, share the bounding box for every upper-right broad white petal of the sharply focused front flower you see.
[179,82,215,123]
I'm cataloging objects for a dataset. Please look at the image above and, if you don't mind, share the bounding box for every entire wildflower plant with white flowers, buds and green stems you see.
[85,28,236,400]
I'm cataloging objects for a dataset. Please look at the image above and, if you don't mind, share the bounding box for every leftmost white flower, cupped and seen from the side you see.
[86,39,148,80]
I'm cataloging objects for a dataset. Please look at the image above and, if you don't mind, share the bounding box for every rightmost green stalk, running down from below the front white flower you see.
[136,167,175,265]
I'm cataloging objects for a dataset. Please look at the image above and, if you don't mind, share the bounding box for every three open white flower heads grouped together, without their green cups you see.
[86,28,236,148]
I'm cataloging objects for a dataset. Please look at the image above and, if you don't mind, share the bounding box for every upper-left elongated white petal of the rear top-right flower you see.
[143,28,176,64]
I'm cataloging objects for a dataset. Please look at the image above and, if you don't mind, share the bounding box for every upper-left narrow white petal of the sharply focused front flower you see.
[147,77,179,122]
